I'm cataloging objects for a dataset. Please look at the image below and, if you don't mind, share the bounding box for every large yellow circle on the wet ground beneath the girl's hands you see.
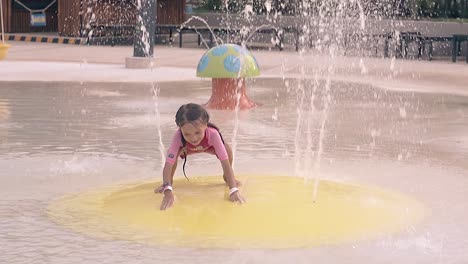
[48,176,424,248]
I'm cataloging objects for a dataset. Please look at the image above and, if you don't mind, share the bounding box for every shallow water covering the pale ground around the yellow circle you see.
[0,79,468,263]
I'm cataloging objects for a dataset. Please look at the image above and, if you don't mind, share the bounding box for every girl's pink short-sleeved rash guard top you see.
[166,127,229,164]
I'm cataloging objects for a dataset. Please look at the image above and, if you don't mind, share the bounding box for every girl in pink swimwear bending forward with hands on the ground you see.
[155,103,245,210]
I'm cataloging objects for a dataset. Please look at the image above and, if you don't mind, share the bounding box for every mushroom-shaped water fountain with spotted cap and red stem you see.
[197,44,260,110]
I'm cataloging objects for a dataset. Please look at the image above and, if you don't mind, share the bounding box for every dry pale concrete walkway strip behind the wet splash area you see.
[0,42,468,95]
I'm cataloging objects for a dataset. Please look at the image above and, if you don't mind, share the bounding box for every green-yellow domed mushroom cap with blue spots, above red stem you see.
[197,44,260,78]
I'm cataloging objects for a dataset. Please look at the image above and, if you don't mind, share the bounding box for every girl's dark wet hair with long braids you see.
[175,103,224,180]
